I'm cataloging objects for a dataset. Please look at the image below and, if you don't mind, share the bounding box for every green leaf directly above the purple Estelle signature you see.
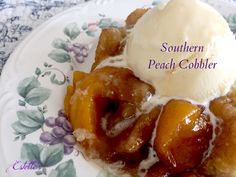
[21,143,43,163]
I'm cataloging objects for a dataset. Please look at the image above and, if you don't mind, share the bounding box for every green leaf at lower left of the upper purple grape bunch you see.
[48,49,71,63]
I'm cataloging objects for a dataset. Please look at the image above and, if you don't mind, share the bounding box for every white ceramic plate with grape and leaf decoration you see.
[0,0,236,177]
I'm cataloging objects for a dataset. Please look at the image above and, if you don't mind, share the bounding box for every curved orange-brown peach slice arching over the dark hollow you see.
[70,67,154,133]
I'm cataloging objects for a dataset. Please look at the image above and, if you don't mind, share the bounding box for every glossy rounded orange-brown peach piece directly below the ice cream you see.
[155,100,213,173]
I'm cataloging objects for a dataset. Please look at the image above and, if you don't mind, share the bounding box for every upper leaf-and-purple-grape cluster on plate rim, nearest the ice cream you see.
[48,14,120,65]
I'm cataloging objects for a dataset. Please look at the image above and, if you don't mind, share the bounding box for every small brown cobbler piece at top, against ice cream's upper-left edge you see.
[125,8,149,28]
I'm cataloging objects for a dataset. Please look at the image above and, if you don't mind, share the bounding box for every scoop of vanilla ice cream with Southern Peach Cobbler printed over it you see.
[124,0,236,102]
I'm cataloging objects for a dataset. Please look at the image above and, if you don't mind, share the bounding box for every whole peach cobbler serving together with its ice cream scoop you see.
[64,0,236,177]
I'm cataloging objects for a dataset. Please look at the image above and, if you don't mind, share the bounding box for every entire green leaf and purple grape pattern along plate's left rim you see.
[12,14,120,177]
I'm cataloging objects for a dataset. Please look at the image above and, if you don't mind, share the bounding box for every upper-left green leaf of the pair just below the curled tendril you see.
[17,77,40,98]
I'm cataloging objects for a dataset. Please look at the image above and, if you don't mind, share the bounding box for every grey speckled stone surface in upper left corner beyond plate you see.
[0,0,89,75]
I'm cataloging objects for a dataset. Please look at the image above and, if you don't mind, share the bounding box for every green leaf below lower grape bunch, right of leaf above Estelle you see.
[40,144,64,167]
